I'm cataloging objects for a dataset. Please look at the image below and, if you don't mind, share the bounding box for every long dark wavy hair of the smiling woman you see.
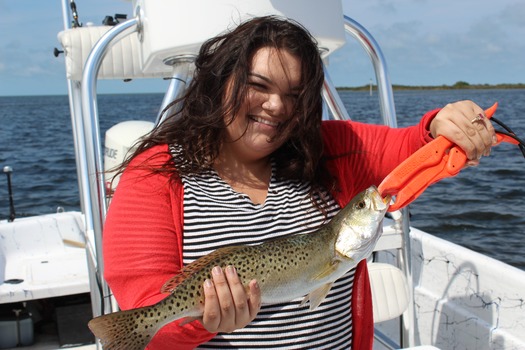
[122,16,330,206]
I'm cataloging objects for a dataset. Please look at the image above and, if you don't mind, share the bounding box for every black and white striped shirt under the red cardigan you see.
[174,152,354,349]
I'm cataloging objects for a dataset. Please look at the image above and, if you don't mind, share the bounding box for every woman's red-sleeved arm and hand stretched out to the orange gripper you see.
[323,101,495,194]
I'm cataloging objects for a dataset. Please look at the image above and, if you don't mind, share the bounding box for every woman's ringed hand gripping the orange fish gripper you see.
[429,101,497,166]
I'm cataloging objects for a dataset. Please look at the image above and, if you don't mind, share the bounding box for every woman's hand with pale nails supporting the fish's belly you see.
[201,266,261,333]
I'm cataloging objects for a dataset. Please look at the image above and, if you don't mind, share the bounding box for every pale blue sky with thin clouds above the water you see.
[0,0,525,96]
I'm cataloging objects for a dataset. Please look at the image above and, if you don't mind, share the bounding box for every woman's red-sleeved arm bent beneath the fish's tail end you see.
[103,146,214,349]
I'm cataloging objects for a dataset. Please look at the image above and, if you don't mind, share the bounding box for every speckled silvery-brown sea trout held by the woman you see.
[89,187,389,350]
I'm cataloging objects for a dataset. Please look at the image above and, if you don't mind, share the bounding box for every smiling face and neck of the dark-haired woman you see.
[214,47,301,204]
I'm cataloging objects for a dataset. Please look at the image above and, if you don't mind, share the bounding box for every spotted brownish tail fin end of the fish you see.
[88,307,162,350]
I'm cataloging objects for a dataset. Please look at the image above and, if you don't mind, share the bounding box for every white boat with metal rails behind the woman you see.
[0,0,525,349]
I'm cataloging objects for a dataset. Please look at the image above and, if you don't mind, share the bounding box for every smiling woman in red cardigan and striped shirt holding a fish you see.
[104,17,495,349]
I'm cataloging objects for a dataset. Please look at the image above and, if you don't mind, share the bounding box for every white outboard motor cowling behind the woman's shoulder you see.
[104,120,155,198]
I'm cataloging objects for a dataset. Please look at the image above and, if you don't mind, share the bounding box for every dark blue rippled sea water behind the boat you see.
[0,90,525,269]
